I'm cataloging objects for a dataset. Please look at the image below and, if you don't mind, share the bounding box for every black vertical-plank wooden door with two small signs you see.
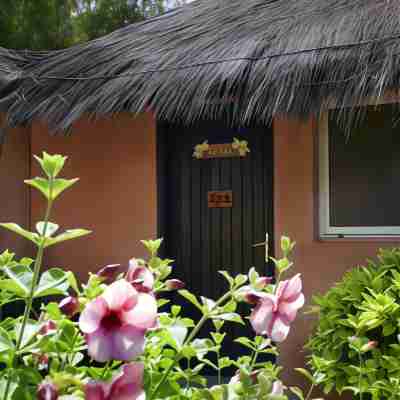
[158,122,273,360]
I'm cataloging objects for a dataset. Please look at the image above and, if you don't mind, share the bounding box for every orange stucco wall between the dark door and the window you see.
[274,118,400,398]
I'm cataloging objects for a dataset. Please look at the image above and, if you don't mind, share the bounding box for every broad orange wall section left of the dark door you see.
[31,114,157,278]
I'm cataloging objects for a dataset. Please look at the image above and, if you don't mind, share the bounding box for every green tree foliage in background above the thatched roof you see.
[0,0,182,50]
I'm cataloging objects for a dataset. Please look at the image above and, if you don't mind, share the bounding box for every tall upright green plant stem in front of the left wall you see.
[3,178,53,400]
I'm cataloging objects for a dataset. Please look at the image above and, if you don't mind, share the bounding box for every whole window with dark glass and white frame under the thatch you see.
[319,104,400,238]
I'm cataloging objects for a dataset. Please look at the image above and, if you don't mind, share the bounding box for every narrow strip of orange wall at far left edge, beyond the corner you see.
[0,116,30,257]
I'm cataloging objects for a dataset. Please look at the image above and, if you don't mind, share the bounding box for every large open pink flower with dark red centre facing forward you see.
[79,279,157,362]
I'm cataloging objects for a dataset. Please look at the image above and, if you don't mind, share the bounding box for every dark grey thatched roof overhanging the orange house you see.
[0,0,400,129]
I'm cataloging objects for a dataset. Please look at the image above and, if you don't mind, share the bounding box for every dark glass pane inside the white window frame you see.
[329,104,400,227]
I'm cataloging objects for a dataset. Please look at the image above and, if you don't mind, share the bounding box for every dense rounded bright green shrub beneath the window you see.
[306,248,400,400]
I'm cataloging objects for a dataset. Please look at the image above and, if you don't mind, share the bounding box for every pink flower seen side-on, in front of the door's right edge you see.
[250,274,304,342]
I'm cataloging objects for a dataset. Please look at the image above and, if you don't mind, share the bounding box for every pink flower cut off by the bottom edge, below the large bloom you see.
[85,363,145,400]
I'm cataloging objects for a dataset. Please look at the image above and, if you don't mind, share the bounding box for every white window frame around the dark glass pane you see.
[318,108,400,239]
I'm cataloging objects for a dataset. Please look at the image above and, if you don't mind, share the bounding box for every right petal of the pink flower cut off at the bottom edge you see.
[109,363,145,400]
